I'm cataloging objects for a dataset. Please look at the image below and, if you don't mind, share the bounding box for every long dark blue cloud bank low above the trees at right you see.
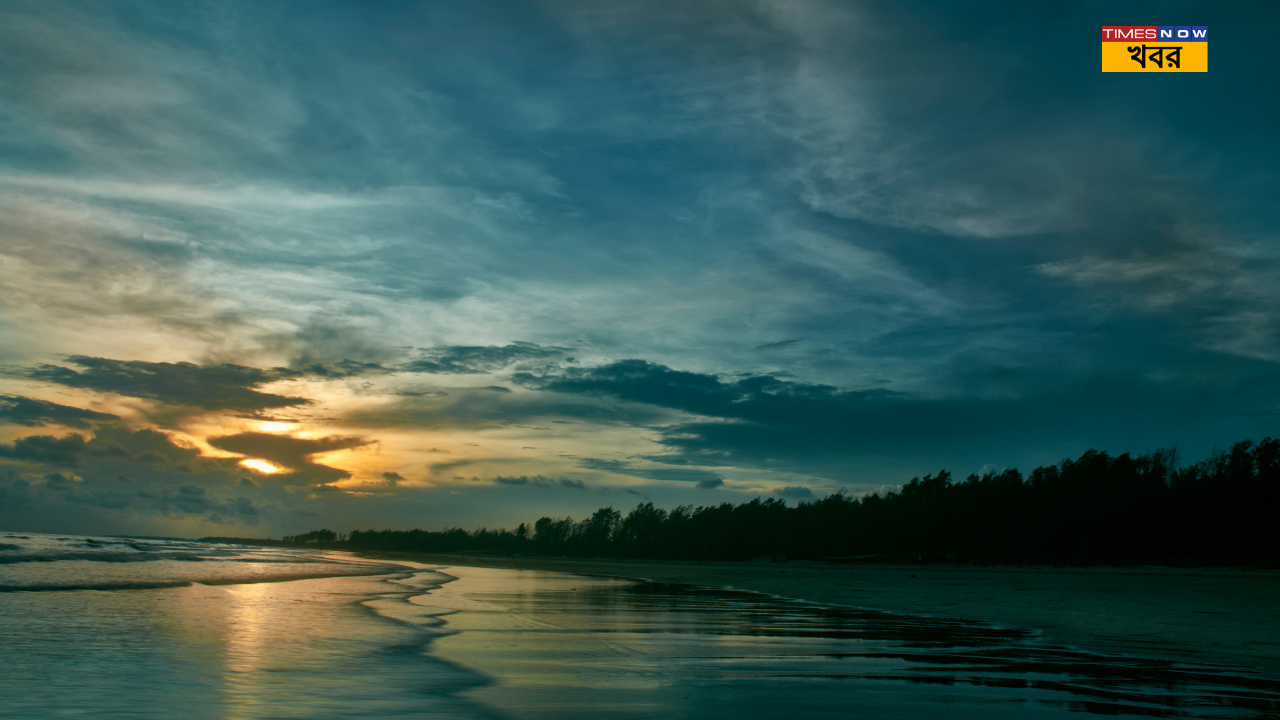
[515,360,1280,479]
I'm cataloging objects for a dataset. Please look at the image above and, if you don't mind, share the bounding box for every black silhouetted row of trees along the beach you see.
[206,438,1280,565]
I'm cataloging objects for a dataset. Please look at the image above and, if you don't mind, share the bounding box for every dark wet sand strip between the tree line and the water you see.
[376,555,1280,671]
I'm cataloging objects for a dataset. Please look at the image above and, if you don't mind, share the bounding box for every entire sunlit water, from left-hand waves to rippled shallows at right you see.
[0,533,1280,720]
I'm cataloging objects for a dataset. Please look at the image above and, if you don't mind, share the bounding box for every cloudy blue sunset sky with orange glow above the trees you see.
[0,0,1280,537]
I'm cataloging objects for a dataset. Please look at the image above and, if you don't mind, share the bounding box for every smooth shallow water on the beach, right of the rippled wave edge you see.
[415,568,1280,717]
